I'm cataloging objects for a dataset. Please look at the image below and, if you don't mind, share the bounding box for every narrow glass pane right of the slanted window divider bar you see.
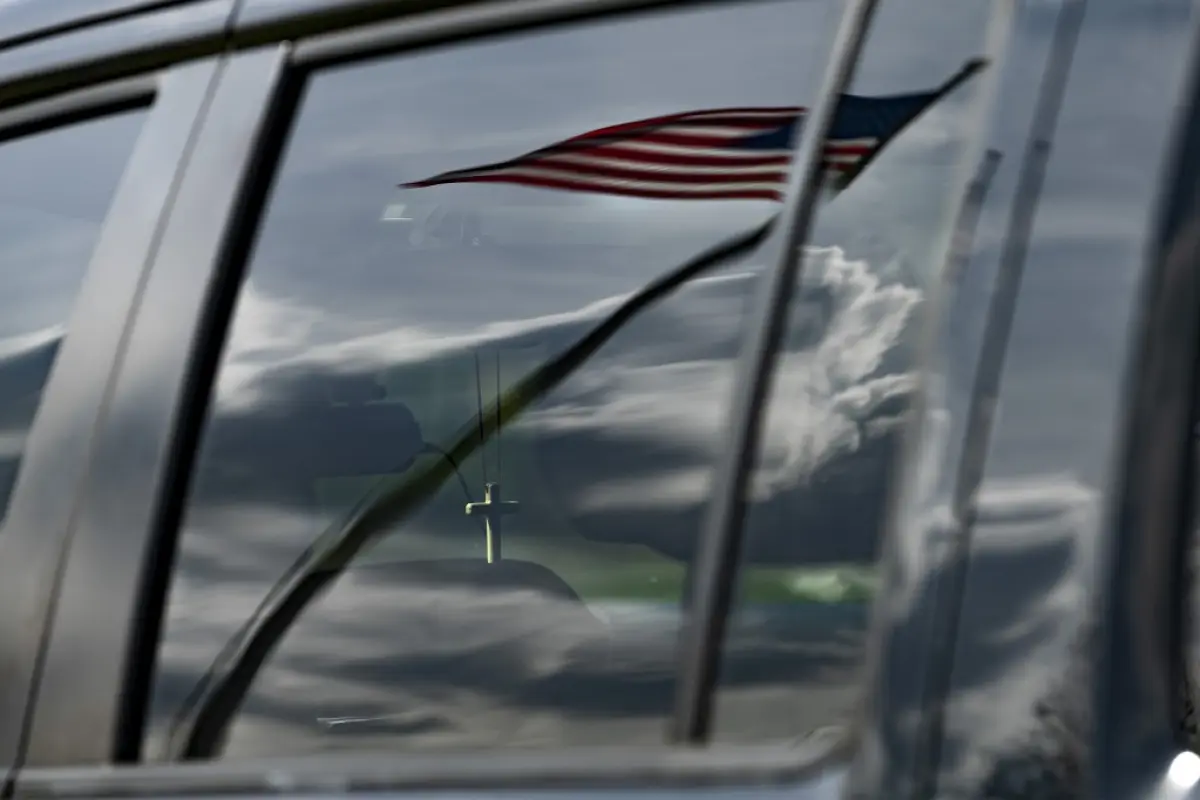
[714,0,998,742]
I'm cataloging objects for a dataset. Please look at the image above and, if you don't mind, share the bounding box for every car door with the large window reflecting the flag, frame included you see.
[2,0,1070,796]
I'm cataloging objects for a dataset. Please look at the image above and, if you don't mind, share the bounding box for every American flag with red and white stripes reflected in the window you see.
[401,59,984,200]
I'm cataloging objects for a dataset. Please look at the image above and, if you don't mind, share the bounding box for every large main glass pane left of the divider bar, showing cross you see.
[148,1,864,758]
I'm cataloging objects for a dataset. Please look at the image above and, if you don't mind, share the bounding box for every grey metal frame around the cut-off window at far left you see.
[0,0,235,782]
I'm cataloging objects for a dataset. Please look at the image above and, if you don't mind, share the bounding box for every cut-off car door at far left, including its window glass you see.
[0,2,233,780]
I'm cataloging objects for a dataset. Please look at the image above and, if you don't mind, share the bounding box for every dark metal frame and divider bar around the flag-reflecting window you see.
[11,0,907,796]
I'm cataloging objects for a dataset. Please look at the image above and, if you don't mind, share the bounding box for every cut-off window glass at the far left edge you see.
[0,112,144,519]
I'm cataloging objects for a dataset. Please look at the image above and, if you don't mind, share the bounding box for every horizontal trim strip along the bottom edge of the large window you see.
[17,747,842,800]
